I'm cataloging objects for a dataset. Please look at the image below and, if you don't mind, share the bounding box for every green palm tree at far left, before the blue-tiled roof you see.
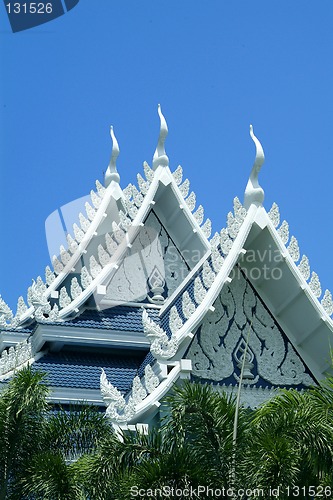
[0,368,113,500]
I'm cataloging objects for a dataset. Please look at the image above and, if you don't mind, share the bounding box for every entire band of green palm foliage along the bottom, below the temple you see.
[0,369,333,500]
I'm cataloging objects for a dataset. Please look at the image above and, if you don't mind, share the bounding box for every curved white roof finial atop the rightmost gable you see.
[244,125,265,210]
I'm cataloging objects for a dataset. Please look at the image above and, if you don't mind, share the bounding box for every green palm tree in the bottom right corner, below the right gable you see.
[241,380,333,499]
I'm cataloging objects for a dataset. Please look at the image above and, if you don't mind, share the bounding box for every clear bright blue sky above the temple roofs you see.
[0,0,333,310]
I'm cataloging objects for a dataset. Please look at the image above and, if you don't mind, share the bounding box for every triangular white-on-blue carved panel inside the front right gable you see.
[187,272,315,387]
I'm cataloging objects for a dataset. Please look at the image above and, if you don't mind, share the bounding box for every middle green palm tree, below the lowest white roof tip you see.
[76,382,248,500]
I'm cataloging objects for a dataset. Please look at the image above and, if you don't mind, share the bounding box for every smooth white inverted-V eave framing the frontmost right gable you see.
[167,204,333,380]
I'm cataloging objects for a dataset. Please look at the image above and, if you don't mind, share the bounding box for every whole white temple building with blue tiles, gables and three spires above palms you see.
[0,107,333,425]
